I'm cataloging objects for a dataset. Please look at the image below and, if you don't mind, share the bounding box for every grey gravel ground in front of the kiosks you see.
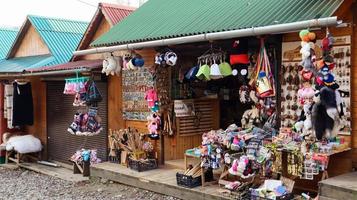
[0,167,176,200]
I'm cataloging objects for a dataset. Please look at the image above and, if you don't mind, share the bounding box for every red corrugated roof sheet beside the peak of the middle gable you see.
[99,3,135,26]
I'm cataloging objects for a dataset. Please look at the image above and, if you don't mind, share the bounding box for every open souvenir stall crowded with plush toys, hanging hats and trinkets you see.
[93,30,349,198]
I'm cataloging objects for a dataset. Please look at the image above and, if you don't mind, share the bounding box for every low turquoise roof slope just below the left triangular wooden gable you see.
[0,55,55,73]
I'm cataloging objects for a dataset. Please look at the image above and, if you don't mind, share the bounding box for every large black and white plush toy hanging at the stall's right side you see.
[312,87,340,140]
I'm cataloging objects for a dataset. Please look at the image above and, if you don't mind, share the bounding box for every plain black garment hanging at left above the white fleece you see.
[12,81,33,126]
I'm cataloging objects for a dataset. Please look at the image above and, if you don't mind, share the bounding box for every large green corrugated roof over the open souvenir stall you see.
[91,0,343,46]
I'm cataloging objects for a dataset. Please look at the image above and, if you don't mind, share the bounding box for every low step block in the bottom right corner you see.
[319,172,357,200]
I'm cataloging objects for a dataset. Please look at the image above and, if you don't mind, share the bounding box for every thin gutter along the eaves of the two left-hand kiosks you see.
[0,68,91,78]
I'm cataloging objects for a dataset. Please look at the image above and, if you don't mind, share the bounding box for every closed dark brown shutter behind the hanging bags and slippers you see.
[47,81,108,162]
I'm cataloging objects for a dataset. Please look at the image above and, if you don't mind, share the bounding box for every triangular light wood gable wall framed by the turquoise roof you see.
[14,25,50,57]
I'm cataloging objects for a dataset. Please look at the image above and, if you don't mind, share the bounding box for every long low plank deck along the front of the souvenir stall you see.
[91,163,232,200]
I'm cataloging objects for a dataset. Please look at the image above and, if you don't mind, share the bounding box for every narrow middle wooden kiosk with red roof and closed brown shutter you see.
[10,3,133,162]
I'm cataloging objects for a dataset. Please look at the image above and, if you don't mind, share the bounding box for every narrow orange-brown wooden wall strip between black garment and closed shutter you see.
[25,77,47,158]
